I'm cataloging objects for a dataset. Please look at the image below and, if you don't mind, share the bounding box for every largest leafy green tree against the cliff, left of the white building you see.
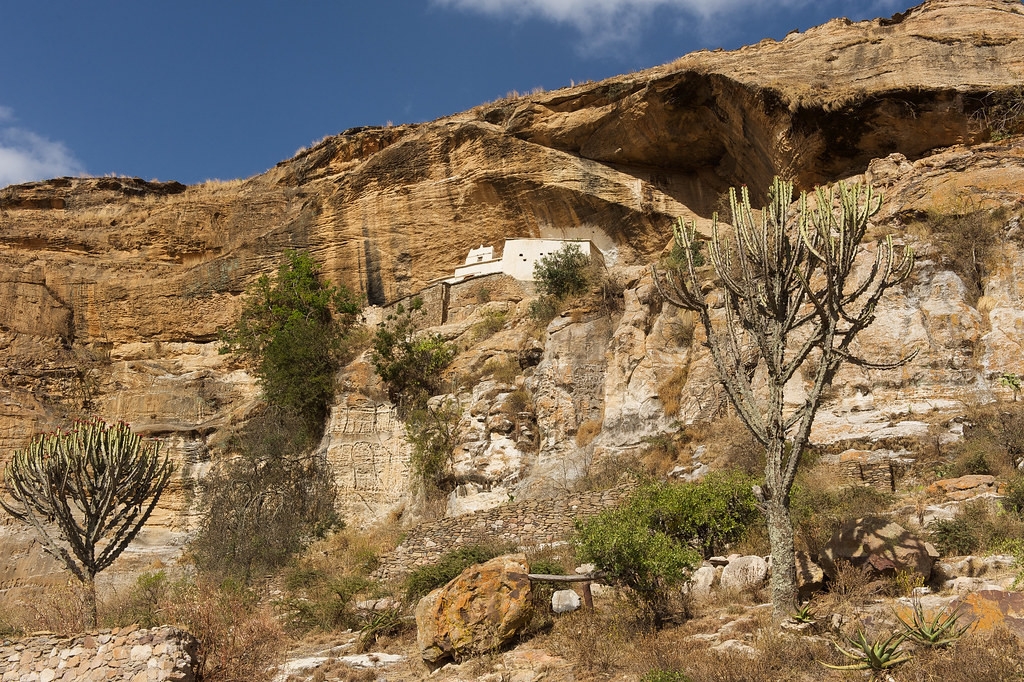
[220,251,359,434]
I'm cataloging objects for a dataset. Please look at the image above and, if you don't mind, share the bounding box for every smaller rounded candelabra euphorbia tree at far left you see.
[0,419,174,627]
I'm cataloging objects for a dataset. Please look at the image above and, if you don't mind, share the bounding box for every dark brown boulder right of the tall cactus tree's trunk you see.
[818,516,938,581]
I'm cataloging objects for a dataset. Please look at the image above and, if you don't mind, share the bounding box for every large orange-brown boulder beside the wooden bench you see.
[416,554,530,664]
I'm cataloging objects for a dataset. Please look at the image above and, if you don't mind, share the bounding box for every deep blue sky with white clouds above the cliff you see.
[0,0,912,186]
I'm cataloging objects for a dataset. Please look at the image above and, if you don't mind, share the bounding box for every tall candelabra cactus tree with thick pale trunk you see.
[654,178,913,620]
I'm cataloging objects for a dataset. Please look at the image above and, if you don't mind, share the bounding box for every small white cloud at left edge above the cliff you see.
[0,106,85,187]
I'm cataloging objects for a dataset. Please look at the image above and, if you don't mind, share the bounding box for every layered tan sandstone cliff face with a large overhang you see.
[0,0,1024,591]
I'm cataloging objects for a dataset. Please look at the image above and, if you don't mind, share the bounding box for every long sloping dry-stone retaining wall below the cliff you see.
[374,481,636,580]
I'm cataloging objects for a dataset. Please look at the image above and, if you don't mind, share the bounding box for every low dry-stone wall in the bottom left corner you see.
[0,626,199,682]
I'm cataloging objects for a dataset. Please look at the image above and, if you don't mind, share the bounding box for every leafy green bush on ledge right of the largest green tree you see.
[371,297,457,416]
